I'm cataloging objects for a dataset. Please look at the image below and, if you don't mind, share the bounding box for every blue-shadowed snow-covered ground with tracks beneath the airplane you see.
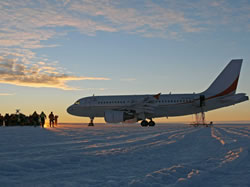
[0,124,250,187]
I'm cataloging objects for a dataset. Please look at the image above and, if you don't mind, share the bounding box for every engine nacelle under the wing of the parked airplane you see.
[104,110,135,123]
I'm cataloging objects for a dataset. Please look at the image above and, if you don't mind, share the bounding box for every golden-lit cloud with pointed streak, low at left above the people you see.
[0,57,109,90]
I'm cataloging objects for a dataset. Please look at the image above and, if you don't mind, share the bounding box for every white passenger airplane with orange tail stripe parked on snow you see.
[67,59,249,127]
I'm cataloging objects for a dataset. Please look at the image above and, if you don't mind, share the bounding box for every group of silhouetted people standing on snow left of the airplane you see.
[0,111,58,128]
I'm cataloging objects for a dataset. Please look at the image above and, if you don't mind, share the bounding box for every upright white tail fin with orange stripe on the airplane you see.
[202,59,243,97]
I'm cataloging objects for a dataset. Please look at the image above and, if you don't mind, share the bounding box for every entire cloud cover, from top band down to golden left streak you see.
[0,0,250,89]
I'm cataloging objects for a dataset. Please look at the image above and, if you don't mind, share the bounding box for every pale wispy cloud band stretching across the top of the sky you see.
[0,0,250,46]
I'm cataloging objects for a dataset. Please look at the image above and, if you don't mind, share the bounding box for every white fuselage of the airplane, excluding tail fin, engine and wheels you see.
[67,94,248,118]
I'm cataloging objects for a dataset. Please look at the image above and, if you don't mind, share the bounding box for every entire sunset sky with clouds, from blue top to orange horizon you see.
[0,0,250,123]
